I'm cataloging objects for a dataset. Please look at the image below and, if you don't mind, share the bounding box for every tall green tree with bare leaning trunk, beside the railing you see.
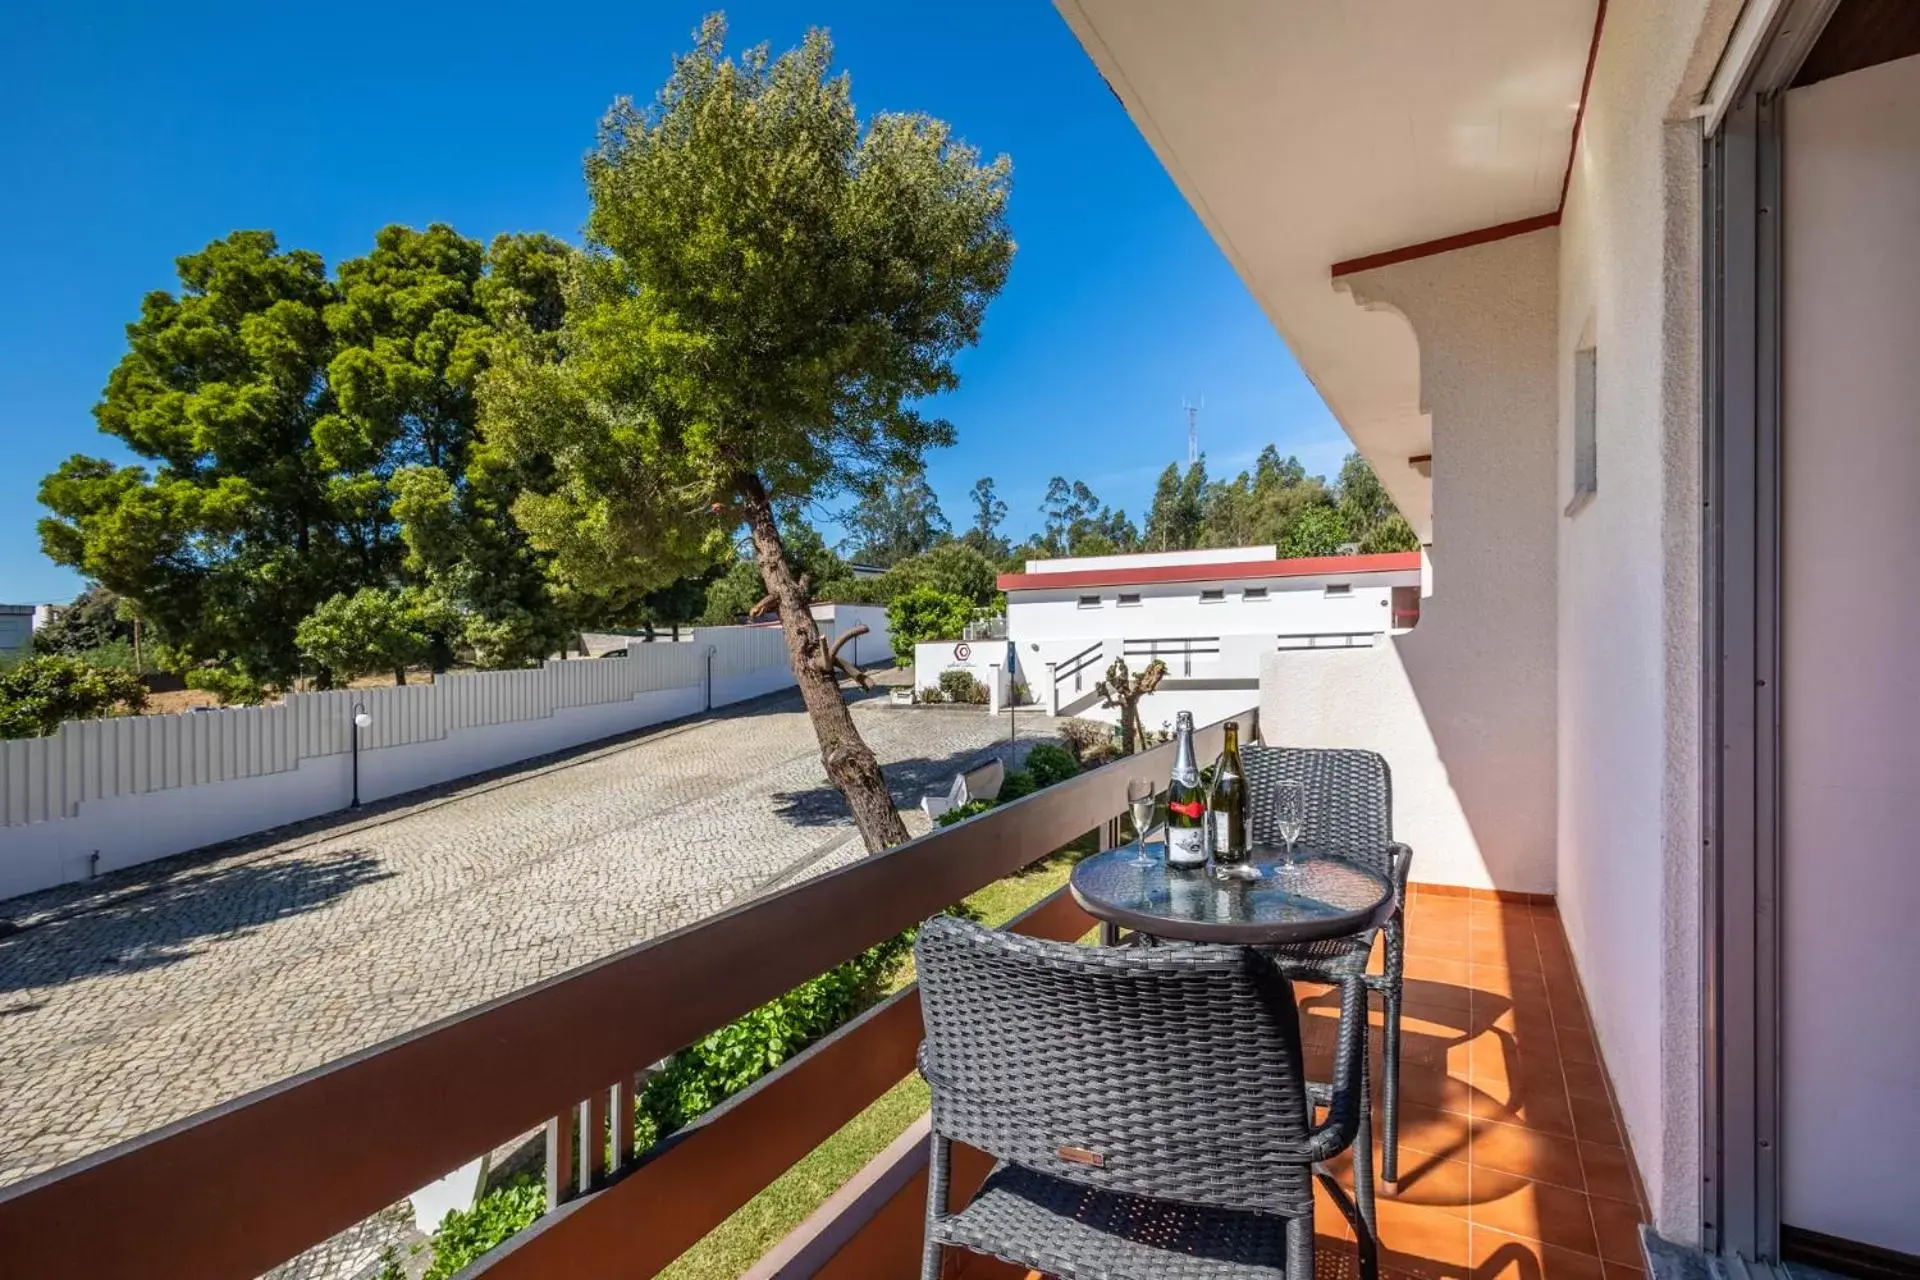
[484,17,1014,850]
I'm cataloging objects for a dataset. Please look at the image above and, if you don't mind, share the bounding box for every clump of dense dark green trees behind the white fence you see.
[40,225,572,683]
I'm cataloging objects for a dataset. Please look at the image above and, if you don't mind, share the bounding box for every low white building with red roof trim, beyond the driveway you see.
[998,547,1421,727]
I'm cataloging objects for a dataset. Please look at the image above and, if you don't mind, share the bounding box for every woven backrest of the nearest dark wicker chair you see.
[914,915,1313,1215]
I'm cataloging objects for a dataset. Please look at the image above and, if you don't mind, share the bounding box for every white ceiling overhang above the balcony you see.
[1054,0,1601,541]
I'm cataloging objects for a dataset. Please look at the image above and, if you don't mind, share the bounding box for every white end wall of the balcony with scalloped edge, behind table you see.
[1336,230,1559,892]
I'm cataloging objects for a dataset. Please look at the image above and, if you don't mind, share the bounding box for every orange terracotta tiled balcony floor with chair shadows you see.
[1300,887,1645,1280]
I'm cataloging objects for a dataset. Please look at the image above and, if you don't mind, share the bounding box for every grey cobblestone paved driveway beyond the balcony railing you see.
[0,695,1050,1184]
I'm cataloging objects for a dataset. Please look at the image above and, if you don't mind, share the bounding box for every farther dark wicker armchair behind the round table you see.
[1240,745,1413,1182]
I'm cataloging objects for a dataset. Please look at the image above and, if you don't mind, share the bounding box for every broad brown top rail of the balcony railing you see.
[0,708,1258,1280]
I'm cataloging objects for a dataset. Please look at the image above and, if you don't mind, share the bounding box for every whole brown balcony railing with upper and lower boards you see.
[0,710,1258,1280]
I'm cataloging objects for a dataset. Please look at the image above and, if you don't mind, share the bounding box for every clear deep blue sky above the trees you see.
[0,0,1346,603]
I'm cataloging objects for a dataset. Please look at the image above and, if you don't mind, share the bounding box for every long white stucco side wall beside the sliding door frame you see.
[1555,0,1732,1244]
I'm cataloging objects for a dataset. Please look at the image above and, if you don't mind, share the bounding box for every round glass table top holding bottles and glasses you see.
[1071,844,1394,946]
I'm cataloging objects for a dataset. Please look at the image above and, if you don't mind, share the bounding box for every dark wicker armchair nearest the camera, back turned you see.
[914,915,1379,1280]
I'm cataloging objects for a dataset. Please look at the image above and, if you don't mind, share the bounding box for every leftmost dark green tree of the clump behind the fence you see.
[40,232,360,677]
